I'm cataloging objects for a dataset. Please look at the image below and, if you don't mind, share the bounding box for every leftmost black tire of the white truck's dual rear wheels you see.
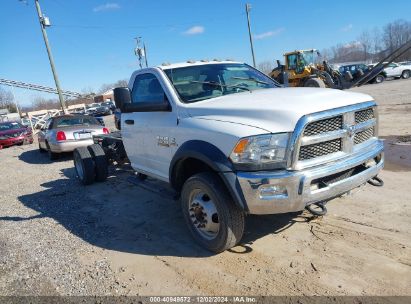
[73,147,96,185]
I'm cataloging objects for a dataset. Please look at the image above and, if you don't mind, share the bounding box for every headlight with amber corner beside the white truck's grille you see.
[230,133,290,170]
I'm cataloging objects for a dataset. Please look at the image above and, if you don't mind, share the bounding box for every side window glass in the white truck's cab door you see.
[131,74,165,103]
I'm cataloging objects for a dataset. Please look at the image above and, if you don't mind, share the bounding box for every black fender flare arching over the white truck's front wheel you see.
[169,140,248,211]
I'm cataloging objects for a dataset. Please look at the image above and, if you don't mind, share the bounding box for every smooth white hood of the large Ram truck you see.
[186,88,373,133]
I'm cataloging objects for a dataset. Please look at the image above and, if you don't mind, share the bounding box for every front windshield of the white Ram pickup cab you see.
[164,63,278,103]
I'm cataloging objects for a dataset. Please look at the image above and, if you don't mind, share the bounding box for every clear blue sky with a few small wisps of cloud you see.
[0,0,411,106]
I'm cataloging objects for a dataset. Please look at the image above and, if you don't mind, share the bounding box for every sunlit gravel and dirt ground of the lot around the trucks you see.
[0,80,411,295]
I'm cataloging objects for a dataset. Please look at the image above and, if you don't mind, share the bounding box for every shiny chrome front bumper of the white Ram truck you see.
[237,140,384,214]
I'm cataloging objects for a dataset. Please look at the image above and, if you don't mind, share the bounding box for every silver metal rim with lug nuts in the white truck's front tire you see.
[188,189,220,240]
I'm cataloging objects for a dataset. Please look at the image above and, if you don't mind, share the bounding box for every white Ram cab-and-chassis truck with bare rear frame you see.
[74,61,384,252]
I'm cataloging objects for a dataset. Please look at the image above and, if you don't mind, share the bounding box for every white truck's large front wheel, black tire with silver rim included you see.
[181,172,244,253]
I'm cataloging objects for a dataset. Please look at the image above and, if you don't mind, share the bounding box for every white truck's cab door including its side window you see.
[122,73,177,181]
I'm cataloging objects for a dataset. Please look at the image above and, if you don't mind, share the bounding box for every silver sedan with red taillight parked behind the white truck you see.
[38,115,109,159]
